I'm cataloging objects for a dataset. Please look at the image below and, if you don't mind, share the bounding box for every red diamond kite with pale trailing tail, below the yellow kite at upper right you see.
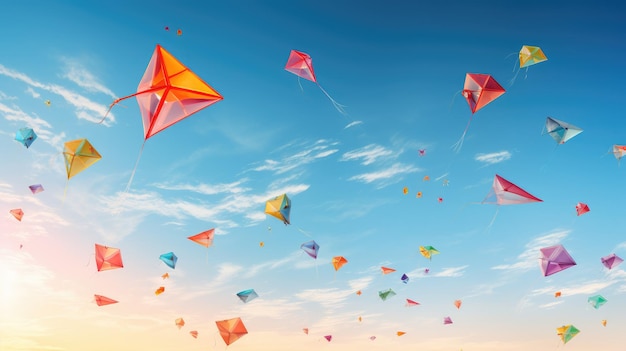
[453,73,506,151]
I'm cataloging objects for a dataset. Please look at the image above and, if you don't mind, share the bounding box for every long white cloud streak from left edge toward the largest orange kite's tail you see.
[0,64,115,125]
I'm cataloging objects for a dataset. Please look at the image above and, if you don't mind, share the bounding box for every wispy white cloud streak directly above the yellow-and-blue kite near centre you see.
[252,139,339,174]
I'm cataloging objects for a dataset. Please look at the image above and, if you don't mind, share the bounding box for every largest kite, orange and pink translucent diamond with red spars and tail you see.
[100,45,224,190]
